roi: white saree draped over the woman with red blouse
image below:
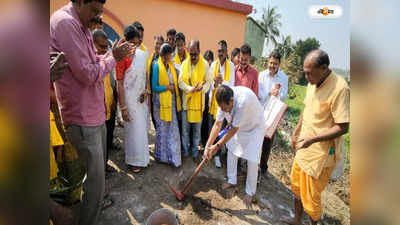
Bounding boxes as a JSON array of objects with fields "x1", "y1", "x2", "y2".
[{"x1": 124, "y1": 49, "x2": 150, "y2": 167}]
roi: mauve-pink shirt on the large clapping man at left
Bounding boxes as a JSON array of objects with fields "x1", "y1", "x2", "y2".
[{"x1": 50, "y1": 3, "x2": 116, "y2": 126}]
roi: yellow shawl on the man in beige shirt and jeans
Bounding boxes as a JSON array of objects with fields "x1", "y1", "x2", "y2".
[{"x1": 182, "y1": 54, "x2": 206, "y2": 123}]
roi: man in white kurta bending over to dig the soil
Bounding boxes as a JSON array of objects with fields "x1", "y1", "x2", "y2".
[{"x1": 204, "y1": 85, "x2": 266, "y2": 208}]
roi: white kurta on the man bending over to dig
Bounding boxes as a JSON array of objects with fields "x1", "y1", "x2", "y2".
[{"x1": 216, "y1": 86, "x2": 266, "y2": 164}]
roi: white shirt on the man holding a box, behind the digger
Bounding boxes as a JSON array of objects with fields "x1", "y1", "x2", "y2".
[{"x1": 258, "y1": 69, "x2": 289, "y2": 106}]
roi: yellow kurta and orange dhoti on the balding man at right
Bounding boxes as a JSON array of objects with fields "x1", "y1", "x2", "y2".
[{"x1": 290, "y1": 73, "x2": 350, "y2": 221}]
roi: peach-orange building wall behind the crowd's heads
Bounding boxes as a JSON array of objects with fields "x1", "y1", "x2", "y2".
[{"x1": 50, "y1": 0, "x2": 247, "y2": 54}]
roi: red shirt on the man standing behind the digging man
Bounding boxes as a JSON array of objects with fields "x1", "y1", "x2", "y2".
[{"x1": 235, "y1": 64, "x2": 258, "y2": 97}]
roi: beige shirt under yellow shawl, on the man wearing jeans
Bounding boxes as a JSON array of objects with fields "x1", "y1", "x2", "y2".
[{"x1": 178, "y1": 58, "x2": 212, "y2": 111}]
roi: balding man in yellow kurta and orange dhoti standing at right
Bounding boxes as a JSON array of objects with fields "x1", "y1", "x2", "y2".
[{"x1": 282, "y1": 50, "x2": 350, "y2": 225}]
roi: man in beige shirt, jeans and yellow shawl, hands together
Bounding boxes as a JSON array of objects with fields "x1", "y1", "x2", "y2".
[{"x1": 178, "y1": 40, "x2": 212, "y2": 162}]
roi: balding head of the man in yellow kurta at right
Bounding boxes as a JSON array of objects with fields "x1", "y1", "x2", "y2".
[{"x1": 303, "y1": 49, "x2": 330, "y2": 85}]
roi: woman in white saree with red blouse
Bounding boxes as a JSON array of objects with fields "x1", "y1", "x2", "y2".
[{"x1": 116, "y1": 25, "x2": 150, "y2": 173}]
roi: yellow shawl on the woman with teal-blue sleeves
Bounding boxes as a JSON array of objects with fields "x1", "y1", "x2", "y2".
[{"x1": 158, "y1": 57, "x2": 181, "y2": 122}]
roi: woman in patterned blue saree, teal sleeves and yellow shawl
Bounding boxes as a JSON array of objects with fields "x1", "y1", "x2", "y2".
[{"x1": 152, "y1": 43, "x2": 181, "y2": 167}]
